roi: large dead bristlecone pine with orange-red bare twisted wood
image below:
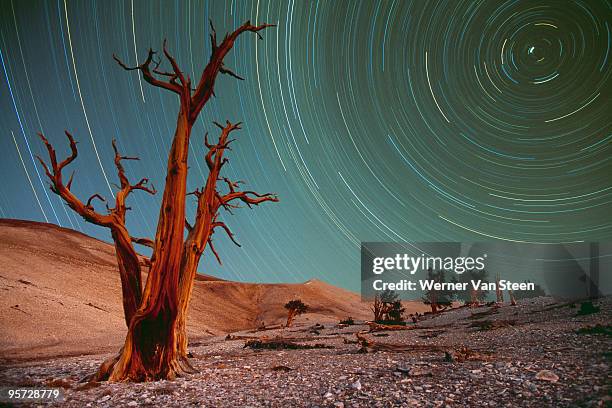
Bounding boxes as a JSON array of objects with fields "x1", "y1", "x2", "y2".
[{"x1": 39, "y1": 21, "x2": 278, "y2": 381}]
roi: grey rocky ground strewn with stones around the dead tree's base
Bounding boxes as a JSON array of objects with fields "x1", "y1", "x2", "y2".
[{"x1": 0, "y1": 298, "x2": 612, "y2": 407}]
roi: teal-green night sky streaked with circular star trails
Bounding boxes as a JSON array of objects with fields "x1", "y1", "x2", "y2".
[{"x1": 0, "y1": 0, "x2": 612, "y2": 290}]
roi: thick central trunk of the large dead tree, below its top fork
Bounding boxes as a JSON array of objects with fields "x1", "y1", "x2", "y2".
[{"x1": 109, "y1": 106, "x2": 191, "y2": 381}]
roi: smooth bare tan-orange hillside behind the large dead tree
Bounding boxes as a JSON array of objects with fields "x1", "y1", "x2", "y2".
[{"x1": 0, "y1": 219, "x2": 430, "y2": 358}]
